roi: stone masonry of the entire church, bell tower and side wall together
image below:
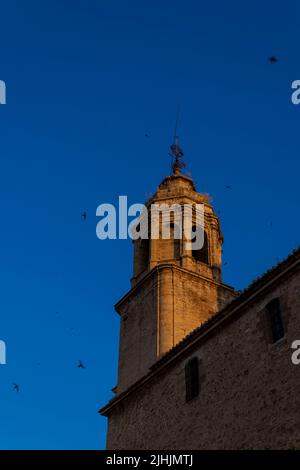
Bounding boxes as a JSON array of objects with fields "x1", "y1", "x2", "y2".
[{"x1": 100, "y1": 168, "x2": 300, "y2": 450}]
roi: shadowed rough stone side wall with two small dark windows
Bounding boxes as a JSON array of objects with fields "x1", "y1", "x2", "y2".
[{"x1": 107, "y1": 271, "x2": 300, "y2": 449}]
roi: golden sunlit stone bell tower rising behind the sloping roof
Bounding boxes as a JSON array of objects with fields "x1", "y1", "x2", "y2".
[{"x1": 114, "y1": 140, "x2": 235, "y2": 394}]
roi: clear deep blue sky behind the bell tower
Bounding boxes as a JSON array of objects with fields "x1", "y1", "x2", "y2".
[{"x1": 0, "y1": 0, "x2": 300, "y2": 449}]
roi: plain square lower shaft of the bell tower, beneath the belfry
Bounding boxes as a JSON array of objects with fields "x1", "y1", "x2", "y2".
[{"x1": 117, "y1": 264, "x2": 234, "y2": 393}]
